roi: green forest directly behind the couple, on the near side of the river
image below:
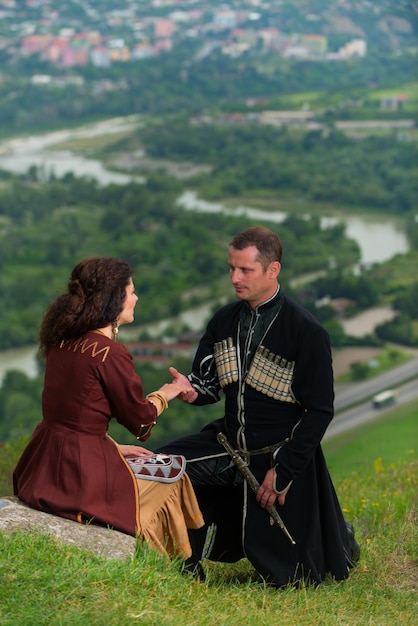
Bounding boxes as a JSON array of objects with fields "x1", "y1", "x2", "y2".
[{"x1": 0, "y1": 168, "x2": 358, "y2": 349}]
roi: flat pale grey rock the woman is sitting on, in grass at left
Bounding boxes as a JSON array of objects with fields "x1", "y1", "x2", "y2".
[{"x1": 0, "y1": 496, "x2": 136, "y2": 559}]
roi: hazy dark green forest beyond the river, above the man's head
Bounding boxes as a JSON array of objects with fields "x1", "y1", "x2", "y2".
[{"x1": 122, "y1": 119, "x2": 418, "y2": 217}]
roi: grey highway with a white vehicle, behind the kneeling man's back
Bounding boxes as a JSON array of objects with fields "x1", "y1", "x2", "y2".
[{"x1": 323, "y1": 358, "x2": 418, "y2": 438}]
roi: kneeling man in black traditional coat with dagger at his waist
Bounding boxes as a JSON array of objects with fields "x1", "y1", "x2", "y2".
[{"x1": 157, "y1": 227, "x2": 358, "y2": 587}]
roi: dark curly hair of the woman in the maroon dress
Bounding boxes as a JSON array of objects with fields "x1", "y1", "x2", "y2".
[{"x1": 39, "y1": 257, "x2": 132, "y2": 356}]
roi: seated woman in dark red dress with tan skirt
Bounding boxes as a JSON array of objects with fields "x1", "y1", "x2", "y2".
[{"x1": 13, "y1": 257, "x2": 203, "y2": 559}]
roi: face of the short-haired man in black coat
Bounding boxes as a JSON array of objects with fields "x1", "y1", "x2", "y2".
[{"x1": 228, "y1": 246, "x2": 280, "y2": 309}]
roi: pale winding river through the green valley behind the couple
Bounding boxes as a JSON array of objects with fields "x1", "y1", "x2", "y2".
[{"x1": 0, "y1": 116, "x2": 409, "y2": 385}]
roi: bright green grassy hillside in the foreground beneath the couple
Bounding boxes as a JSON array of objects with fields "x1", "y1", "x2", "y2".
[{"x1": 0, "y1": 402, "x2": 418, "y2": 626}]
